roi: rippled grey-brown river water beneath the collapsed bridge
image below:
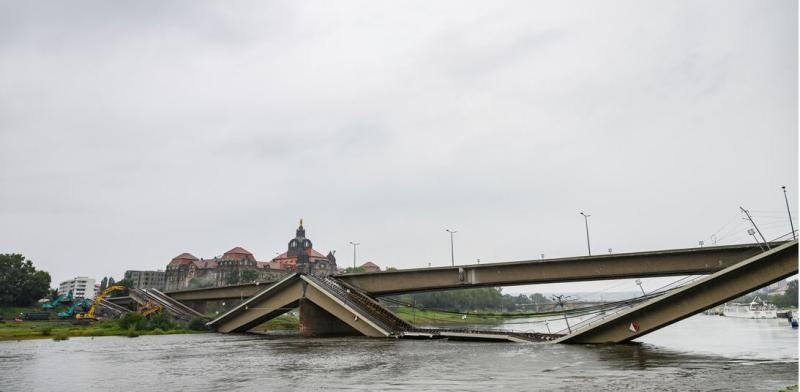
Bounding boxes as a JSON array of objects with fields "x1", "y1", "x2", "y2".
[{"x1": 0, "y1": 315, "x2": 798, "y2": 392}]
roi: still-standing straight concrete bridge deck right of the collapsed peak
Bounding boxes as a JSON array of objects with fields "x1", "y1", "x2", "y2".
[{"x1": 336, "y1": 244, "x2": 777, "y2": 296}]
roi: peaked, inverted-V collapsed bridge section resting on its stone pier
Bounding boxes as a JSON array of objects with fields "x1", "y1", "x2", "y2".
[{"x1": 207, "y1": 273, "x2": 411, "y2": 337}]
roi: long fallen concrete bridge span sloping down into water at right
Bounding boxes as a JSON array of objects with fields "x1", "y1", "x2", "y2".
[{"x1": 555, "y1": 240, "x2": 797, "y2": 343}]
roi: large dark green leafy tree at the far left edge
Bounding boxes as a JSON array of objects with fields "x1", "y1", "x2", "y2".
[{"x1": 0, "y1": 254, "x2": 50, "y2": 306}]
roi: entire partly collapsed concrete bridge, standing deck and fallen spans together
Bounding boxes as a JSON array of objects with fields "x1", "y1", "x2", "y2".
[{"x1": 114, "y1": 241, "x2": 797, "y2": 343}]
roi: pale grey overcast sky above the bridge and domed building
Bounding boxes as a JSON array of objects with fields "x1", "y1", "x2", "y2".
[{"x1": 0, "y1": 0, "x2": 800, "y2": 289}]
